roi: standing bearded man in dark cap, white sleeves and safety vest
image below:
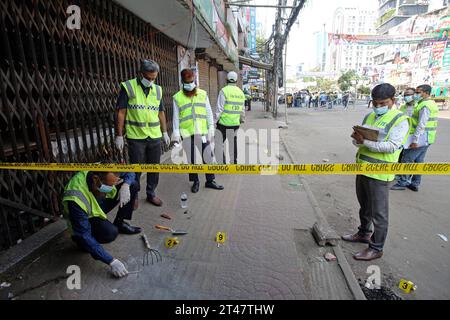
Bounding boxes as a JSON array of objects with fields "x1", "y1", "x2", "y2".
[{"x1": 172, "y1": 69, "x2": 224, "y2": 193}]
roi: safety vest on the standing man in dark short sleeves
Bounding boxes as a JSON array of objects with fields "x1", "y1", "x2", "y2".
[{"x1": 122, "y1": 79, "x2": 162, "y2": 140}]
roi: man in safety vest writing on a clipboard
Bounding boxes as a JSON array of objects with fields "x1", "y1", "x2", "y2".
[{"x1": 342, "y1": 83, "x2": 409, "y2": 261}]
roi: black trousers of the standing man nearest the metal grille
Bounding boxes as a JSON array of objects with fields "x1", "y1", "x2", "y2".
[{"x1": 128, "y1": 138, "x2": 161, "y2": 198}]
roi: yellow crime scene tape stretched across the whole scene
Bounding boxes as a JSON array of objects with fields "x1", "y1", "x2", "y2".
[{"x1": 0, "y1": 163, "x2": 450, "y2": 175}]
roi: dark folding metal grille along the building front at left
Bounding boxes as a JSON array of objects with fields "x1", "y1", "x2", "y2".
[{"x1": 0, "y1": 0, "x2": 178, "y2": 250}]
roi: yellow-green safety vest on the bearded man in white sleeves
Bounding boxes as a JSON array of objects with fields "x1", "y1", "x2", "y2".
[{"x1": 173, "y1": 89, "x2": 208, "y2": 138}]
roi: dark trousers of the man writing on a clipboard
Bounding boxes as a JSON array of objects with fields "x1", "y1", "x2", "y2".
[{"x1": 356, "y1": 175, "x2": 389, "y2": 251}]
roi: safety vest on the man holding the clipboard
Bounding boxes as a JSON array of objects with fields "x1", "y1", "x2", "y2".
[{"x1": 356, "y1": 110, "x2": 408, "y2": 181}]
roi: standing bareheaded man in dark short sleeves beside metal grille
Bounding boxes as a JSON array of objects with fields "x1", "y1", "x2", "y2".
[{"x1": 116, "y1": 60, "x2": 170, "y2": 207}]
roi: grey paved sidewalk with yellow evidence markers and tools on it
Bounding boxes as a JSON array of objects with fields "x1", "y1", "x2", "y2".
[{"x1": 0, "y1": 104, "x2": 353, "y2": 300}]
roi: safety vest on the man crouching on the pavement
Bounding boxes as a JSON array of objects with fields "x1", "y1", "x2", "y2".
[{"x1": 62, "y1": 171, "x2": 117, "y2": 229}]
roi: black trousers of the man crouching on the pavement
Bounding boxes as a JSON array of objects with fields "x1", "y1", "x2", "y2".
[{"x1": 89, "y1": 183, "x2": 138, "y2": 244}]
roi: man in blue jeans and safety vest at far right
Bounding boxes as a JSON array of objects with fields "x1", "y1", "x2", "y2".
[{"x1": 391, "y1": 85, "x2": 439, "y2": 192}]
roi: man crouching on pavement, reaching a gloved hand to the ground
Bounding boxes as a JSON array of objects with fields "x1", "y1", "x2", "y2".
[{"x1": 63, "y1": 171, "x2": 141, "y2": 278}]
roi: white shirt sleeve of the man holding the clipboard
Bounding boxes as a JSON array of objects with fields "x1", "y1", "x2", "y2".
[{"x1": 353, "y1": 112, "x2": 409, "y2": 153}]
